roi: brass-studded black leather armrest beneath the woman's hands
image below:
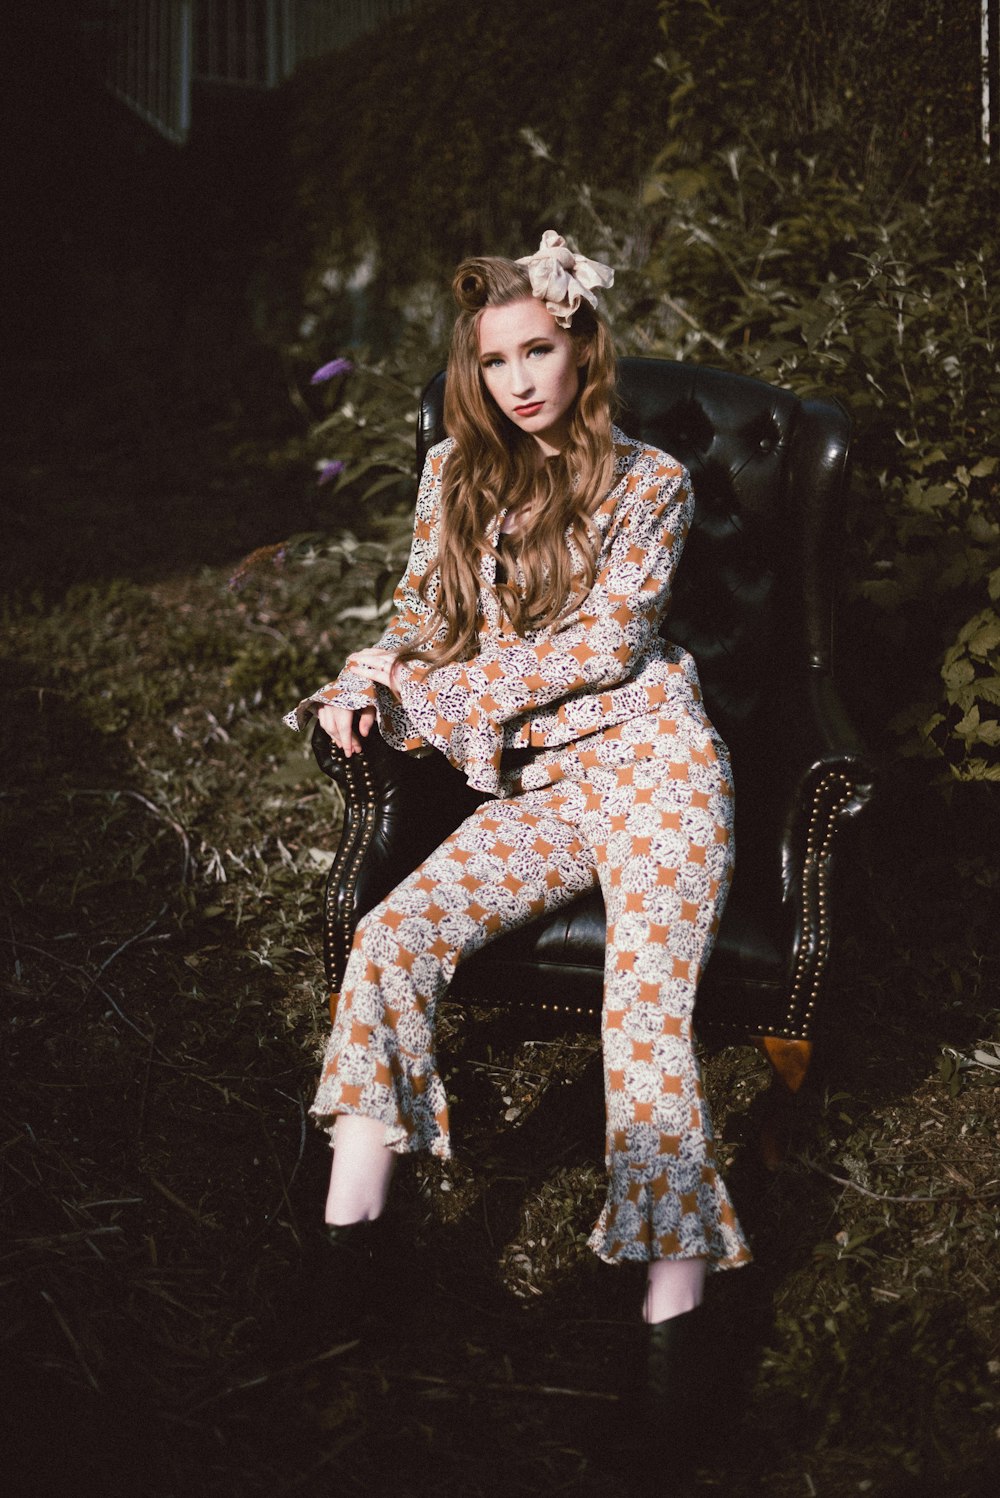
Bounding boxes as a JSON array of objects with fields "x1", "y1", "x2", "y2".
[{"x1": 313, "y1": 724, "x2": 484, "y2": 989}]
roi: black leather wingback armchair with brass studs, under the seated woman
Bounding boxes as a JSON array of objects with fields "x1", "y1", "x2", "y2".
[{"x1": 313, "y1": 358, "x2": 873, "y2": 1091}]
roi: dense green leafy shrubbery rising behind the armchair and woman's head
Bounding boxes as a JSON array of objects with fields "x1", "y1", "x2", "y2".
[{"x1": 264, "y1": 0, "x2": 1000, "y2": 779}]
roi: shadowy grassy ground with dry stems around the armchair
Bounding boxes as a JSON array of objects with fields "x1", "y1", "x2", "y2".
[{"x1": 0, "y1": 404, "x2": 1000, "y2": 1498}]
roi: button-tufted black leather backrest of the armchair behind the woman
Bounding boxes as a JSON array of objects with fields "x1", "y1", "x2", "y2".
[{"x1": 418, "y1": 358, "x2": 850, "y2": 753}]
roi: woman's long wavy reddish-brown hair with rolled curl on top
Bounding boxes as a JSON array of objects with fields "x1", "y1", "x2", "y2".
[{"x1": 403, "y1": 256, "x2": 617, "y2": 665}]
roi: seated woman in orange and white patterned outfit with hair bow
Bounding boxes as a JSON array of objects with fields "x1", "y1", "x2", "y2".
[{"x1": 289, "y1": 231, "x2": 750, "y2": 1414}]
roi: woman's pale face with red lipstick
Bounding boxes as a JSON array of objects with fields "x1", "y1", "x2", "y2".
[{"x1": 479, "y1": 297, "x2": 590, "y2": 457}]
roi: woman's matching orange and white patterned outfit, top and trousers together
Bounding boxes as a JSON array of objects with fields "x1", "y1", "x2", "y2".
[{"x1": 286, "y1": 428, "x2": 750, "y2": 1267}]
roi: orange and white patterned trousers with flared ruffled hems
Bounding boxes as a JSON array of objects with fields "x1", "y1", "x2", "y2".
[{"x1": 311, "y1": 710, "x2": 750, "y2": 1269}]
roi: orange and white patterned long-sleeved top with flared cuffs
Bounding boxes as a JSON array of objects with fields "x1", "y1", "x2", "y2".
[{"x1": 284, "y1": 427, "x2": 705, "y2": 795}]
